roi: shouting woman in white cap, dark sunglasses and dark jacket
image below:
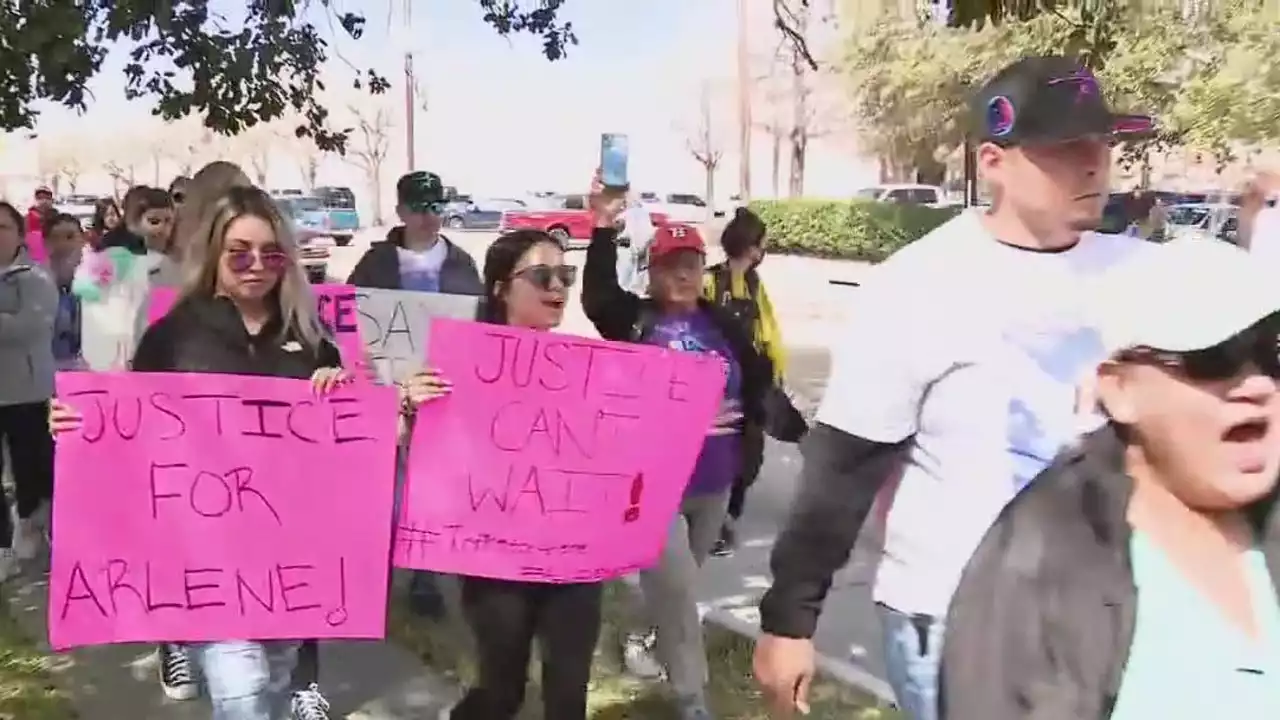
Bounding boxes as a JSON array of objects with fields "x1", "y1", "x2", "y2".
[{"x1": 938, "y1": 240, "x2": 1280, "y2": 720}]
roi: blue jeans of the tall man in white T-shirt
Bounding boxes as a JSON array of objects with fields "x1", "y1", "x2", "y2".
[{"x1": 876, "y1": 605, "x2": 943, "y2": 720}]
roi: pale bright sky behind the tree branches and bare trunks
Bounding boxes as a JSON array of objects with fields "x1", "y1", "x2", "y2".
[{"x1": 7, "y1": 0, "x2": 870, "y2": 206}]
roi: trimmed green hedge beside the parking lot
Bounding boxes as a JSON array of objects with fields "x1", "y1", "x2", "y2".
[{"x1": 751, "y1": 200, "x2": 960, "y2": 261}]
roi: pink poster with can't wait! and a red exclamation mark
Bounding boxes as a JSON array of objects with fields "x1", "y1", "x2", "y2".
[{"x1": 393, "y1": 318, "x2": 724, "y2": 583}]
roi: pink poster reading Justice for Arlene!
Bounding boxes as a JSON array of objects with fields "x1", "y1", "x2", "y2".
[{"x1": 49, "y1": 373, "x2": 397, "y2": 648}]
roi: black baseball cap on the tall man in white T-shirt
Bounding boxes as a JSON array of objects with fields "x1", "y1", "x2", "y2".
[{"x1": 970, "y1": 55, "x2": 1156, "y2": 147}]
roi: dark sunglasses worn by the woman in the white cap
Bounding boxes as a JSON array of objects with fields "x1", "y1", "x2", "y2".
[{"x1": 1121, "y1": 323, "x2": 1280, "y2": 382}]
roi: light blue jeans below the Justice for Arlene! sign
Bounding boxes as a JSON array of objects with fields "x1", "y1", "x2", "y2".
[{"x1": 188, "y1": 641, "x2": 298, "y2": 720}]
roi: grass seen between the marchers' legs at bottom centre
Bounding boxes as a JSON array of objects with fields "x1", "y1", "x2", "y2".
[{"x1": 389, "y1": 583, "x2": 899, "y2": 720}]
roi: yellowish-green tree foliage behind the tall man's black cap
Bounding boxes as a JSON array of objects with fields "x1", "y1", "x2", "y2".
[{"x1": 844, "y1": 0, "x2": 1280, "y2": 178}]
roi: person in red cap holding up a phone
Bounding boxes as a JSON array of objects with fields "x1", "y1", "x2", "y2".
[{"x1": 582, "y1": 174, "x2": 773, "y2": 720}]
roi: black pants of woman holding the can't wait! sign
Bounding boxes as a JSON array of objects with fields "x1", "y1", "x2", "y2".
[{"x1": 449, "y1": 578, "x2": 604, "y2": 720}]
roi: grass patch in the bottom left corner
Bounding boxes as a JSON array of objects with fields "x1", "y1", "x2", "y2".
[{"x1": 0, "y1": 591, "x2": 77, "y2": 720}]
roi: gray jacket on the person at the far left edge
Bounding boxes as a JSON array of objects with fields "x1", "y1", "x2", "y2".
[{"x1": 0, "y1": 251, "x2": 58, "y2": 405}]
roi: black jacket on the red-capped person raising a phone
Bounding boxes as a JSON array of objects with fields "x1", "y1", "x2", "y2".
[{"x1": 582, "y1": 228, "x2": 773, "y2": 425}]
